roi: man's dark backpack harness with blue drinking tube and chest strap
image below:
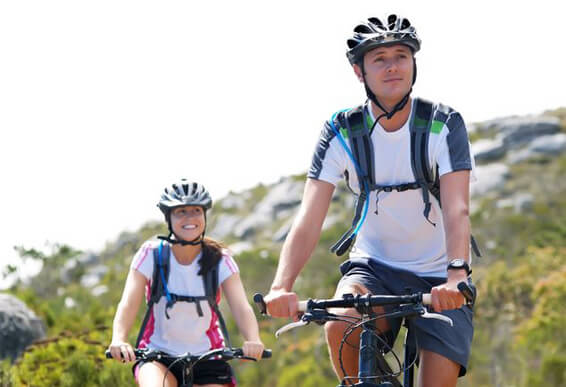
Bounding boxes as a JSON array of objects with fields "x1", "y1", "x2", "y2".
[{"x1": 329, "y1": 98, "x2": 481, "y2": 257}]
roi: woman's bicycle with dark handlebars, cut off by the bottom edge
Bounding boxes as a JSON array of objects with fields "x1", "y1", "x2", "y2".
[{"x1": 105, "y1": 348, "x2": 271, "y2": 387}]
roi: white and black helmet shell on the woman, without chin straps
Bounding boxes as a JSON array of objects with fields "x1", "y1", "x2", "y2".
[{"x1": 157, "y1": 179, "x2": 212, "y2": 218}]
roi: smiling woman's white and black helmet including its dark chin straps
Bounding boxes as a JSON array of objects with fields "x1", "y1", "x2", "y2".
[{"x1": 157, "y1": 179, "x2": 212, "y2": 245}]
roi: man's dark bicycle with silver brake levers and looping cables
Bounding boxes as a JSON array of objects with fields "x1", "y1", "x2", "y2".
[{"x1": 254, "y1": 282, "x2": 475, "y2": 387}]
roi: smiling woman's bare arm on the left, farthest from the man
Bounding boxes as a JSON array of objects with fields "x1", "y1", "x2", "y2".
[{"x1": 109, "y1": 269, "x2": 147, "y2": 361}]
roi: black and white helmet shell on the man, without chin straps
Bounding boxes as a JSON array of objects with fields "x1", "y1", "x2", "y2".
[{"x1": 346, "y1": 14, "x2": 421, "y2": 65}]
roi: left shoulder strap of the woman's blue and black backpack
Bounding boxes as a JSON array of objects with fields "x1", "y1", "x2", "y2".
[{"x1": 136, "y1": 241, "x2": 171, "y2": 348}]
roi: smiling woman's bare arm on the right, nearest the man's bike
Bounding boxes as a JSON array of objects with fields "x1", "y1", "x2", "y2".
[{"x1": 222, "y1": 273, "x2": 264, "y2": 359}]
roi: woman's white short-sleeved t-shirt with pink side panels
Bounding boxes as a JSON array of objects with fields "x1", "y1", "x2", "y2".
[{"x1": 130, "y1": 241, "x2": 239, "y2": 356}]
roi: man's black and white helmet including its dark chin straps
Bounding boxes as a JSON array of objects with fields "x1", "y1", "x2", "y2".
[{"x1": 346, "y1": 14, "x2": 421, "y2": 123}]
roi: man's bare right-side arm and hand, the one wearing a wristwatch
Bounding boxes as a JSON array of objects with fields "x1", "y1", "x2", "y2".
[{"x1": 431, "y1": 170, "x2": 470, "y2": 312}]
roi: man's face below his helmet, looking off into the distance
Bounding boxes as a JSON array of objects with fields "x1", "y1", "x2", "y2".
[{"x1": 354, "y1": 44, "x2": 414, "y2": 104}]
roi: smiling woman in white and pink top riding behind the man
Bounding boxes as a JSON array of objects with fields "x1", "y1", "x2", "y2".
[{"x1": 109, "y1": 179, "x2": 264, "y2": 387}]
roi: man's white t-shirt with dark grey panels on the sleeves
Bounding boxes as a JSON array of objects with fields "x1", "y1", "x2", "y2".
[{"x1": 307, "y1": 100, "x2": 474, "y2": 277}]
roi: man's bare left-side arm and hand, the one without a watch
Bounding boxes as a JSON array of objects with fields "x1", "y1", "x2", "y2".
[{"x1": 265, "y1": 179, "x2": 334, "y2": 317}]
